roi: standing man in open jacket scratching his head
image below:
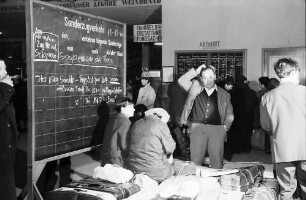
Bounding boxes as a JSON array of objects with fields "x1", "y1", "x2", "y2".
[{"x1": 178, "y1": 64, "x2": 234, "y2": 169}]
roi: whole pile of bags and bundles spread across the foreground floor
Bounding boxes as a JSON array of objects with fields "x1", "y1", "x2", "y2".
[{"x1": 44, "y1": 164, "x2": 279, "y2": 200}]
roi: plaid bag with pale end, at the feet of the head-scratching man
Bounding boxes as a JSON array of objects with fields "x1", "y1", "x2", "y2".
[{"x1": 220, "y1": 165, "x2": 265, "y2": 192}]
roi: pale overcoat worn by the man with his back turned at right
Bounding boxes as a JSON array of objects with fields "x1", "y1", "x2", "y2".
[{"x1": 260, "y1": 82, "x2": 306, "y2": 163}]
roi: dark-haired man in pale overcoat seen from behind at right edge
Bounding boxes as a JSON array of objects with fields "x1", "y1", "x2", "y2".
[{"x1": 260, "y1": 58, "x2": 306, "y2": 200}]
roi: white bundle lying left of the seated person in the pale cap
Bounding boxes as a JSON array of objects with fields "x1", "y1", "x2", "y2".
[{"x1": 93, "y1": 164, "x2": 134, "y2": 183}]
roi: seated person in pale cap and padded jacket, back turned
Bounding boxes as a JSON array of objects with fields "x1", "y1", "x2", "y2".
[{"x1": 127, "y1": 108, "x2": 176, "y2": 181}]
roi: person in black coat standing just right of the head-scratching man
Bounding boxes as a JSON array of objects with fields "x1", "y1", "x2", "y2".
[{"x1": 229, "y1": 76, "x2": 259, "y2": 153}]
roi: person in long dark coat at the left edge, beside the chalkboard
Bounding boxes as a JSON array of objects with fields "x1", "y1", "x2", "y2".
[{"x1": 0, "y1": 60, "x2": 17, "y2": 200}]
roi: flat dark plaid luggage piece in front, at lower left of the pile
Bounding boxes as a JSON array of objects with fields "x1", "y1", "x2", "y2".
[{"x1": 44, "y1": 178, "x2": 140, "y2": 200}]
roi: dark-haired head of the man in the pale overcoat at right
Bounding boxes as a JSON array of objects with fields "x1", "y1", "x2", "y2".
[{"x1": 274, "y1": 58, "x2": 299, "y2": 78}]
